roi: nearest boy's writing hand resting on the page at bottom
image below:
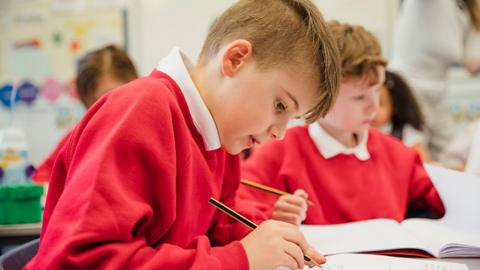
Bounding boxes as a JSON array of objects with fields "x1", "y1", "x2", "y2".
[{"x1": 240, "y1": 220, "x2": 325, "y2": 270}]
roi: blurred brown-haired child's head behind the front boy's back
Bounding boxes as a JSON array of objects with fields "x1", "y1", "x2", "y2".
[{"x1": 75, "y1": 45, "x2": 138, "y2": 109}]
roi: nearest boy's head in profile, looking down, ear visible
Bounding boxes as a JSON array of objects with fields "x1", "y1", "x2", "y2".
[{"x1": 193, "y1": 0, "x2": 340, "y2": 153}]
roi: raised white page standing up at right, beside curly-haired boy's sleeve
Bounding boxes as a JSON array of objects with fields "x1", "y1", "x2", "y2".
[{"x1": 425, "y1": 164, "x2": 480, "y2": 234}]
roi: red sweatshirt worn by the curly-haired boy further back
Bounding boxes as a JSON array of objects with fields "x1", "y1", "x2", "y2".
[{"x1": 239, "y1": 126, "x2": 444, "y2": 224}]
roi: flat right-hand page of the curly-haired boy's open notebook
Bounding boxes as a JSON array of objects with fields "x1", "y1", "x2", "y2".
[{"x1": 402, "y1": 218, "x2": 480, "y2": 257}]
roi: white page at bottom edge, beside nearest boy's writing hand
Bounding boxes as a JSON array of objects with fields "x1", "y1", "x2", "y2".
[{"x1": 304, "y1": 254, "x2": 468, "y2": 270}]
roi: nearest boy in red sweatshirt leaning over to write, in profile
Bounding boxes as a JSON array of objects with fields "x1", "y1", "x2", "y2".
[{"x1": 27, "y1": 0, "x2": 339, "y2": 270}]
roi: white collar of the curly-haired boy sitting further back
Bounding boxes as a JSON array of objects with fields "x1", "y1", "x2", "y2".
[{"x1": 308, "y1": 123, "x2": 370, "y2": 160}]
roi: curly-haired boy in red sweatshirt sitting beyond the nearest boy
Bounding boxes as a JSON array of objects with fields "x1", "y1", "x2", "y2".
[{"x1": 240, "y1": 22, "x2": 444, "y2": 225}]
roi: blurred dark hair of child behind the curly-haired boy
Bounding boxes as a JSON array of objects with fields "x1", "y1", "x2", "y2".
[{"x1": 385, "y1": 70, "x2": 424, "y2": 139}]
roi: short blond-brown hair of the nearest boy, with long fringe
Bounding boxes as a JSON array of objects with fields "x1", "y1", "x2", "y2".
[{"x1": 199, "y1": 0, "x2": 340, "y2": 122}]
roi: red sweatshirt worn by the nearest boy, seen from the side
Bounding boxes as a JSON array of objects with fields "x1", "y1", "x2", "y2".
[{"x1": 25, "y1": 71, "x2": 265, "y2": 270}]
